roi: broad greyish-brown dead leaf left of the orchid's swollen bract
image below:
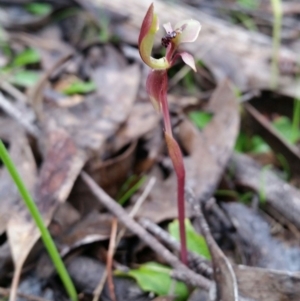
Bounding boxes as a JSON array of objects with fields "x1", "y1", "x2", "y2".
[{"x1": 44, "y1": 65, "x2": 140, "y2": 156}]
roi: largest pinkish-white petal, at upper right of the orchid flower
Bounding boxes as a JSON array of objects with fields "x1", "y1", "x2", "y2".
[{"x1": 174, "y1": 19, "x2": 201, "y2": 45}]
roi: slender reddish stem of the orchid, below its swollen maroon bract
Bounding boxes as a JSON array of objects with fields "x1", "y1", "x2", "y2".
[{"x1": 160, "y1": 92, "x2": 187, "y2": 264}]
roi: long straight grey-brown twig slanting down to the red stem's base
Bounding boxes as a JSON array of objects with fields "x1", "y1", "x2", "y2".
[{"x1": 81, "y1": 171, "x2": 211, "y2": 290}]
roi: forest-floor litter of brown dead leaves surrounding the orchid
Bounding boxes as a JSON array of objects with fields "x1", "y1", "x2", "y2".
[{"x1": 0, "y1": 0, "x2": 300, "y2": 301}]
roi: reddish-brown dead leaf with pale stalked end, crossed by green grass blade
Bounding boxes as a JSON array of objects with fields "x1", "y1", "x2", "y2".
[{"x1": 7, "y1": 130, "x2": 86, "y2": 300}]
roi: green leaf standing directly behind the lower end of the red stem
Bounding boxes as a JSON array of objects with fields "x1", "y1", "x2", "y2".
[{"x1": 168, "y1": 219, "x2": 211, "y2": 259}]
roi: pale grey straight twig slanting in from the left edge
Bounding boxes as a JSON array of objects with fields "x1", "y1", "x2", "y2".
[{"x1": 0, "y1": 92, "x2": 40, "y2": 139}]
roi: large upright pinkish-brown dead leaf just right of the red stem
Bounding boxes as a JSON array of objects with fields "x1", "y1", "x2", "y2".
[{"x1": 179, "y1": 81, "x2": 240, "y2": 200}]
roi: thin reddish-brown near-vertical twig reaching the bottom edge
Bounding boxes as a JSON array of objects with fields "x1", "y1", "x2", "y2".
[{"x1": 106, "y1": 218, "x2": 118, "y2": 301}]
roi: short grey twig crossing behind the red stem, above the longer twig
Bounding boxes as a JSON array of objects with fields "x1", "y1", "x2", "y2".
[{"x1": 139, "y1": 218, "x2": 213, "y2": 279}]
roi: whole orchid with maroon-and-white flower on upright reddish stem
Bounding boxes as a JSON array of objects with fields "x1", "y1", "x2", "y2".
[{"x1": 138, "y1": 4, "x2": 201, "y2": 263}]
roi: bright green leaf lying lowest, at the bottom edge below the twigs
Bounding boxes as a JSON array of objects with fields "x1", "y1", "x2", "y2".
[{"x1": 115, "y1": 262, "x2": 189, "y2": 301}]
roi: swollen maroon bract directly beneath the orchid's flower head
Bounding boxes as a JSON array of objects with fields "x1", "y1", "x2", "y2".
[{"x1": 146, "y1": 70, "x2": 168, "y2": 112}]
